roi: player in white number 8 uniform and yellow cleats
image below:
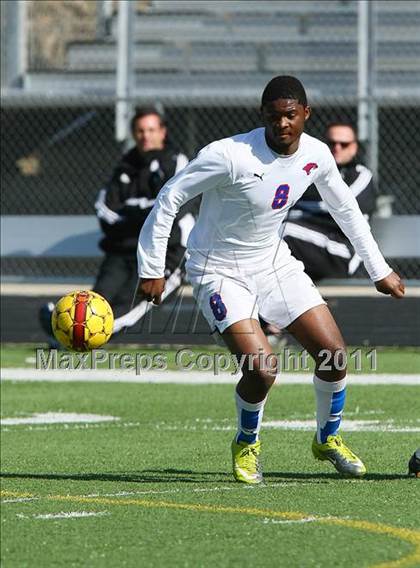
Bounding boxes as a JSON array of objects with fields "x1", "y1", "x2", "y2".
[{"x1": 138, "y1": 76, "x2": 404, "y2": 483}]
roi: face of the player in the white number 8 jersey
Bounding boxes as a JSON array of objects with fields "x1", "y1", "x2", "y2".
[{"x1": 261, "y1": 99, "x2": 311, "y2": 154}]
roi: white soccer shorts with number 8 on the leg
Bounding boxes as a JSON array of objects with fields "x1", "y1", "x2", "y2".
[{"x1": 187, "y1": 255, "x2": 325, "y2": 333}]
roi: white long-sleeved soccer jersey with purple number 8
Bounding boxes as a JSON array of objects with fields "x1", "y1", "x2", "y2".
[{"x1": 138, "y1": 128, "x2": 392, "y2": 281}]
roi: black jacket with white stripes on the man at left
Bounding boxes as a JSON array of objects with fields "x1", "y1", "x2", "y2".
[{"x1": 95, "y1": 146, "x2": 197, "y2": 271}]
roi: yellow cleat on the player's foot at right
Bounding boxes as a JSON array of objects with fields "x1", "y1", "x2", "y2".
[{"x1": 312, "y1": 435, "x2": 366, "y2": 477}]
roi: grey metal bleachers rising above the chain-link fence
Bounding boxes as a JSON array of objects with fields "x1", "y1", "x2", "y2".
[{"x1": 25, "y1": 0, "x2": 420, "y2": 97}]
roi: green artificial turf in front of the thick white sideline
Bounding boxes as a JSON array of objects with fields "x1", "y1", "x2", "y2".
[{"x1": 1, "y1": 381, "x2": 420, "y2": 568}]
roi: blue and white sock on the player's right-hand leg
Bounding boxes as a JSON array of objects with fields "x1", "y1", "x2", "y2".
[{"x1": 314, "y1": 376, "x2": 346, "y2": 444}]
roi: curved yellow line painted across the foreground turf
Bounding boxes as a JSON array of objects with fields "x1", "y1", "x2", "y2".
[{"x1": 0, "y1": 491, "x2": 420, "y2": 568}]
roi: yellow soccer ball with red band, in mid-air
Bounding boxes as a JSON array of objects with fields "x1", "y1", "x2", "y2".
[{"x1": 51, "y1": 290, "x2": 114, "y2": 351}]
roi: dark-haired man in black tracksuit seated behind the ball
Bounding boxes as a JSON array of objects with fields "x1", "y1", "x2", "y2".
[{"x1": 93, "y1": 109, "x2": 194, "y2": 333}]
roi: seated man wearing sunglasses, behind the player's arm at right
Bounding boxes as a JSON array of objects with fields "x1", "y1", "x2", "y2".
[{"x1": 283, "y1": 122, "x2": 375, "y2": 282}]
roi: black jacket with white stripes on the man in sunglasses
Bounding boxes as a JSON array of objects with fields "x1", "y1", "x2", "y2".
[{"x1": 288, "y1": 160, "x2": 376, "y2": 242}]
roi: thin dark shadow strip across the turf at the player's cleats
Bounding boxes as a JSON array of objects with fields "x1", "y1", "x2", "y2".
[{"x1": 0, "y1": 469, "x2": 408, "y2": 483}]
